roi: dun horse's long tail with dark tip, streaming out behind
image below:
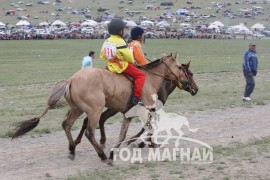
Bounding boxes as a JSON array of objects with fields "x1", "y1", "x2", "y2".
[{"x1": 12, "y1": 80, "x2": 70, "y2": 139}]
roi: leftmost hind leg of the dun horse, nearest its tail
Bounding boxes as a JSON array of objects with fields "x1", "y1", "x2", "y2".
[{"x1": 62, "y1": 108, "x2": 83, "y2": 159}]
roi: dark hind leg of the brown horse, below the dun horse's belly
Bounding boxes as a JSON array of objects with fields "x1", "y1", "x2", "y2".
[{"x1": 99, "y1": 109, "x2": 118, "y2": 145}]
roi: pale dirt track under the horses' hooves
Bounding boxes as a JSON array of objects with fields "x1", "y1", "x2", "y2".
[{"x1": 0, "y1": 104, "x2": 270, "y2": 179}]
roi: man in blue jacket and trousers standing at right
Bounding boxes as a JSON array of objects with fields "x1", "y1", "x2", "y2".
[{"x1": 243, "y1": 43, "x2": 258, "y2": 101}]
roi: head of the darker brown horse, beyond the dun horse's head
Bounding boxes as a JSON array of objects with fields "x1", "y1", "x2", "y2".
[{"x1": 179, "y1": 61, "x2": 199, "y2": 96}]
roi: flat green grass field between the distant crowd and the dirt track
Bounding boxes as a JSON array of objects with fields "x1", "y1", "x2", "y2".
[{"x1": 0, "y1": 39, "x2": 270, "y2": 137}]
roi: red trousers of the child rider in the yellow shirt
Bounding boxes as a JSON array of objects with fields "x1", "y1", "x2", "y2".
[{"x1": 123, "y1": 63, "x2": 145, "y2": 99}]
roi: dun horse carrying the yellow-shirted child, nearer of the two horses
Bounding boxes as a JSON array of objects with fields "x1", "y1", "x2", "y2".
[{"x1": 12, "y1": 52, "x2": 194, "y2": 164}]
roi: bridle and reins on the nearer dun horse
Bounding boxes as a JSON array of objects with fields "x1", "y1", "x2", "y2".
[{"x1": 139, "y1": 56, "x2": 186, "y2": 89}]
